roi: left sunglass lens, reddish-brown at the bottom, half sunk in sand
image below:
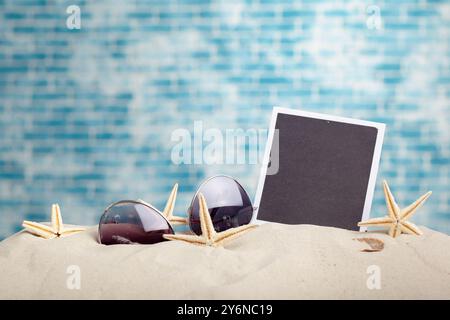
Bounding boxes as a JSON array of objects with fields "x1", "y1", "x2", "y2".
[{"x1": 98, "y1": 201, "x2": 174, "y2": 245}]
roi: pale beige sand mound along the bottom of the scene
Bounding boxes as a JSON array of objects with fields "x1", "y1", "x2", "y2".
[{"x1": 0, "y1": 224, "x2": 450, "y2": 299}]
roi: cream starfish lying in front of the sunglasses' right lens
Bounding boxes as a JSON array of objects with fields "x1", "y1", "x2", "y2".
[{"x1": 163, "y1": 193, "x2": 256, "y2": 247}]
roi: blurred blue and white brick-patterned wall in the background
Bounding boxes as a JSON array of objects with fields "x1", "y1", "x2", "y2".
[{"x1": 0, "y1": 0, "x2": 450, "y2": 238}]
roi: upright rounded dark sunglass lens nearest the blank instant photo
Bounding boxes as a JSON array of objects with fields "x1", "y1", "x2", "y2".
[{"x1": 188, "y1": 176, "x2": 253, "y2": 235}]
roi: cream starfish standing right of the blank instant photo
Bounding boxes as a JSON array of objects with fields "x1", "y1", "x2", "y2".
[{"x1": 358, "y1": 181, "x2": 431, "y2": 238}]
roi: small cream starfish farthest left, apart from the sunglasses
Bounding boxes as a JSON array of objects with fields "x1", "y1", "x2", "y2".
[{"x1": 22, "y1": 204, "x2": 86, "y2": 239}]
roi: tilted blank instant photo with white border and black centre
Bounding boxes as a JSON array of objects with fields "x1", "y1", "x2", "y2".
[{"x1": 254, "y1": 107, "x2": 385, "y2": 231}]
